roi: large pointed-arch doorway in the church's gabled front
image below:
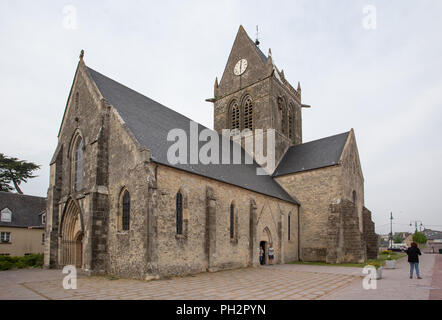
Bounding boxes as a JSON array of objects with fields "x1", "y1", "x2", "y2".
[{"x1": 60, "y1": 200, "x2": 83, "y2": 268}]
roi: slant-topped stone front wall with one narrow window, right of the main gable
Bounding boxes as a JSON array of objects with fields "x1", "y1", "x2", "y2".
[{"x1": 107, "y1": 107, "x2": 155, "y2": 278}]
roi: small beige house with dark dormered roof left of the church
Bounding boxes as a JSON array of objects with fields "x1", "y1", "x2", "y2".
[{"x1": 0, "y1": 191, "x2": 46, "y2": 256}]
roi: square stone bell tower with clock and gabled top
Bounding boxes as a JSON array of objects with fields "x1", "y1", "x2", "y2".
[{"x1": 207, "y1": 26, "x2": 308, "y2": 170}]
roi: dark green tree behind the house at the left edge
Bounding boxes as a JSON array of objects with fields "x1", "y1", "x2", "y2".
[{"x1": 0, "y1": 153, "x2": 40, "y2": 194}]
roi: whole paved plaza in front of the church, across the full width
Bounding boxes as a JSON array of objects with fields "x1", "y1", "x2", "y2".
[{"x1": 0, "y1": 255, "x2": 442, "y2": 300}]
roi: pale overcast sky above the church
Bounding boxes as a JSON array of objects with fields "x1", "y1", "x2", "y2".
[{"x1": 0, "y1": 0, "x2": 442, "y2": 233}]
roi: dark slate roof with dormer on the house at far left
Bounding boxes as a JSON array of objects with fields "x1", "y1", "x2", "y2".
[{"x1": 0, "y1": 191, "x2": 46, "y2": 228}]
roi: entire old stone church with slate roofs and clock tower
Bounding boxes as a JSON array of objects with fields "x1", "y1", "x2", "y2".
[{"x1": 45, "y1": 26, "x2": 378, "y2": 279}]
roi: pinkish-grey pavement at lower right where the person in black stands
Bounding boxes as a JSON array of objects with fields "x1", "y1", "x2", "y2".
[{"x1": 320, "y1": 254, "x2": 442, "y2": 300}]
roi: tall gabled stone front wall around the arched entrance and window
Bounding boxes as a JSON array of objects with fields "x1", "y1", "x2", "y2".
[{"x1": 45, "y1": 60, "x2": 107, "y2": 271}]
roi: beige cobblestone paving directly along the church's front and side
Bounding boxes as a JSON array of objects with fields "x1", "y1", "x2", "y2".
[{"x1": 0, "y1": 265, "x2": 361, "y2": 300}]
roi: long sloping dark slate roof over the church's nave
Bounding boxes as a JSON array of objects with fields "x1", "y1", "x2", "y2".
[{"x1": 87, "y1": 67, "x2": 299, "y2": 203}]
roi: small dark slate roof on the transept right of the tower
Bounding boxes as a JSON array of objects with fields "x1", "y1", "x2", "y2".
[{"x1": 273, "y1": 132, "x2": 350, "y2": 177}]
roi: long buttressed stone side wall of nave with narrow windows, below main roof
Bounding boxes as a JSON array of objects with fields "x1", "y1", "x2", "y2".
[{"x1": 153, "y1": 165, "x2": 298, "y2": 275}]
